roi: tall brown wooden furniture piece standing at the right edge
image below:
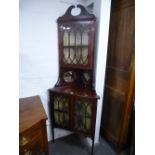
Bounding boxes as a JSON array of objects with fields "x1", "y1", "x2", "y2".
[{"x1": 100, "y1": 0, "x2": 135, "y2": 151}]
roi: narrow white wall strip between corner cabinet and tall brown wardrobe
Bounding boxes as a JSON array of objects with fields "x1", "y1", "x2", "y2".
[{"x1": 87, "y1": 0, "x2": 111, "y2": 143}]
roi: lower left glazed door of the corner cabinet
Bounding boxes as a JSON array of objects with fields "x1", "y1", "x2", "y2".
[{"x1": 53, "y1": 94, "x2": 70, "y2": 128}]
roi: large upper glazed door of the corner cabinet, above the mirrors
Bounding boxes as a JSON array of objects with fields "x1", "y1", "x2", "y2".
[{"x1": 59, "y1": 21, "x2": 94, "y2": 68}]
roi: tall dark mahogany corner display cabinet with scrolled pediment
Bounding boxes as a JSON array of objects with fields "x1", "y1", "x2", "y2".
[{"x1": 49, "y1": 5, "x2": 99, "y2": 154}]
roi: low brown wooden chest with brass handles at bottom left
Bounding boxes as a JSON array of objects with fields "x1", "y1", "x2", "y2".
[{"x1": 19, "y1": 96, "x2": 48, "y2": 155}]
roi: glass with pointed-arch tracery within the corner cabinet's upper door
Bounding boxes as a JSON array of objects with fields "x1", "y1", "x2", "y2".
[{"x1": 63, "y1": 26, "x2": 89, "y2": 65}]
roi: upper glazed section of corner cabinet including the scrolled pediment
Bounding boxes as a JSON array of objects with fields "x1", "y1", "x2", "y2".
[{"x1": 58, "y1": 5, "x2": 96, "y2": 69}]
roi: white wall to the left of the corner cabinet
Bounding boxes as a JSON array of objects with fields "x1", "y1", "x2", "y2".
[{"x1": 19, "y1": 0, "x2": 85, "y2": 140}]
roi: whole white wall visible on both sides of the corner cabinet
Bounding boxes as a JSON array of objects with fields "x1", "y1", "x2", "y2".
[{"x1": 19, "y1": 0, "x2": 110, "y2": 142}]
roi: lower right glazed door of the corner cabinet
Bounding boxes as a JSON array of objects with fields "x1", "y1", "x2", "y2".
[{"x1": 73, "y1": 98, "x2": 96, "y2": 135}]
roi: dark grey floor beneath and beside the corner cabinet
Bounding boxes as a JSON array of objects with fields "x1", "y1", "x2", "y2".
[{"x1": 49, "y1": 134, "x2": 130, "y2": 155}]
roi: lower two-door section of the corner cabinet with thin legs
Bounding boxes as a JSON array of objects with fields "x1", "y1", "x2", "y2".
[{"x1": 49, "y1": 89, "x2": 98, "y2": 155}]
